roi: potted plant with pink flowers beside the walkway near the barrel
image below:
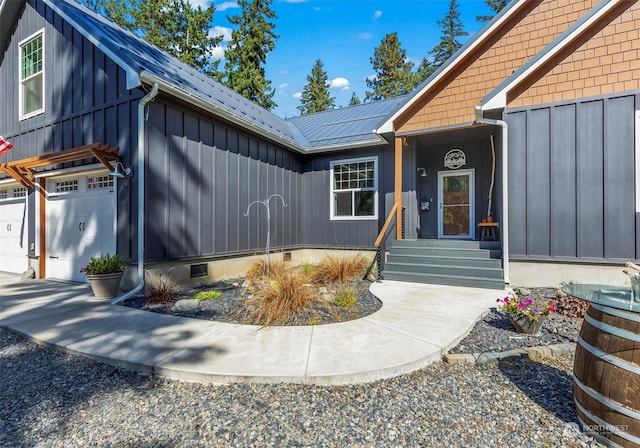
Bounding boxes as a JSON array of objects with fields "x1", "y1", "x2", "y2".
[{"x1": 496, "y1": 293, "x2": 555, "y2": 336}]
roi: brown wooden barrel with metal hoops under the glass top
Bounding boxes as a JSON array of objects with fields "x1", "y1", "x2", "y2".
[{"x1": 573, "y1": 303, "x2": 640, "y2": 448}]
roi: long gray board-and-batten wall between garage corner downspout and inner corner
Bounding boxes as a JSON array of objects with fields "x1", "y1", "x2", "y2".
[{"x1": 145, "y1": 99, "x2": 302, "y2": 262}]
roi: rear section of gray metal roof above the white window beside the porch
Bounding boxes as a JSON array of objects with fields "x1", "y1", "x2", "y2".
[{"x1": 287, "y1": 95, "x2": 409, "y2": 150}]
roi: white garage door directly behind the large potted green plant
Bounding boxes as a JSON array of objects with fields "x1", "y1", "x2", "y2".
[{"x1": 46, "y1": 174, "x2": 116, "y2": 282}]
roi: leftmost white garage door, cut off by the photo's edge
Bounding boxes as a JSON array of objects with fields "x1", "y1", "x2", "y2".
[{"x1": 0, "y1": 183, "x2": 29, "y2": 273}]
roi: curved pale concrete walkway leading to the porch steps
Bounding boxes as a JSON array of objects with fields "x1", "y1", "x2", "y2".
[{"x1": 0, "y1": 273, "x2": 505, "y2": 385}]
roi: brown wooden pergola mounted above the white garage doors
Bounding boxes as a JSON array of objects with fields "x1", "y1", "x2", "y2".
[{"x1": 0, "y1": 143, "x2": 120, "y2": 188}]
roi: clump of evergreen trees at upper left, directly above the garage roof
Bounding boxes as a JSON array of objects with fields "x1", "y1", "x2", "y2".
[{"x1": 79, "y1": 0, "x2": 222, "y2": 76}]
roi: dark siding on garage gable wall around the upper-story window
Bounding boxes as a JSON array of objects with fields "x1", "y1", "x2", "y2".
[{"x1": 0, "y1": 0, "x2": 143, "y2": 258}]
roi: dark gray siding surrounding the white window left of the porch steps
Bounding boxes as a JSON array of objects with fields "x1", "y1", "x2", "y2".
[{"x1": 302, "y1": 145, "x2": 394, "y2": 248}]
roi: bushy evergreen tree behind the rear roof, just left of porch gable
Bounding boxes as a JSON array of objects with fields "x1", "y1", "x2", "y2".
[{"x1": 365, "y1": 32, "x2": 418, "y2": 101}]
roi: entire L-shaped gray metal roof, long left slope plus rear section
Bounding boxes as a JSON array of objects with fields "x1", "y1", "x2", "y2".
[{"x1": 26, "y1": 0, "x2": 409, "y2": 152}]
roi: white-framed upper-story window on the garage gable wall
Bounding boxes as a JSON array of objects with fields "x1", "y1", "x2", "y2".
[{"x1": 19, "y1": 31, "x2": 44, "y2": 119}]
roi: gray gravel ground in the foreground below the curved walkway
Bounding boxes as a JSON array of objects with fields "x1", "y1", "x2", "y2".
[{"x1": 0, "y1": 328, "x2": 597, "y2": 448}]
